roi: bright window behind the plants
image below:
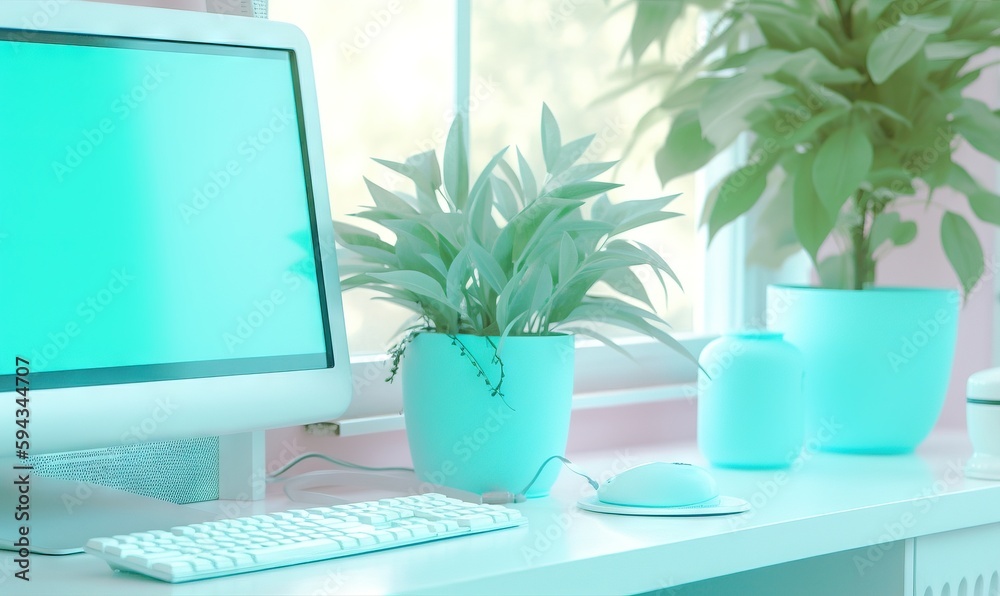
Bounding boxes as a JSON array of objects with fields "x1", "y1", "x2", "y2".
[{"x1": 270, "y1": 0, "x2": 796, "y2": 428}]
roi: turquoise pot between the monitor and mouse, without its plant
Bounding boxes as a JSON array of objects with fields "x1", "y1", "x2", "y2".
[{"x1": 401, "y1": 333, "x2": 575, "y2": 497}]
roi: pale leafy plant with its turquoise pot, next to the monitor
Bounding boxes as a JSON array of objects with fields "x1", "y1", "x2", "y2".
[{"x1": 334, "y1": 106, "x2": 683, "y2": 496}]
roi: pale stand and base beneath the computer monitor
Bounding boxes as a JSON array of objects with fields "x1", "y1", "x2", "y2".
[{"x1": 0, "y1": 431, "x2": 264, "y2": 555}]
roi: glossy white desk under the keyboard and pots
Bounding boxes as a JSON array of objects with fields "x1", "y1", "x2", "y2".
[{"x1": 0, "y1": 435, "x2": 1000, "y2": 596}]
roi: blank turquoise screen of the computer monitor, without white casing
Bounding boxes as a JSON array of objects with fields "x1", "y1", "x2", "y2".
[{"x1": 0, "y1": 32, "x2": 332, "y2": 388}]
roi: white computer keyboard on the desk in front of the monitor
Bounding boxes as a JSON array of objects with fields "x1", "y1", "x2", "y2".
[{"x1": 85, "y1": 493, "x2": 527, "y2": 583}]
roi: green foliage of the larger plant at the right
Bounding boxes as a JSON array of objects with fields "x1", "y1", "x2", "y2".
[{"x1": 628, "y1": 0, "x2": 1000, "y2": 292}]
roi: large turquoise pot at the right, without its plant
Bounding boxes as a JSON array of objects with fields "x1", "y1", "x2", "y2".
[{"x1": 767, "y1": 286, "x2": 961, "y2": 454}]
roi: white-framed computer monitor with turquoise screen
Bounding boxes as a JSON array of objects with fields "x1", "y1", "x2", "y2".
[{"x1": 0, "y1": 1, "x2": 351, "y2": 548}]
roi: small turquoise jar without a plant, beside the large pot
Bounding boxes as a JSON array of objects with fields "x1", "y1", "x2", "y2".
[{"x1": 698, "y1": 331, "x2": 805, "y2": 468}]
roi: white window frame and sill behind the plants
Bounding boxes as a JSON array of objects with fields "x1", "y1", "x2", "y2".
[{"x1": 324, "y1": 0, "x2": 808, "y2": 436}]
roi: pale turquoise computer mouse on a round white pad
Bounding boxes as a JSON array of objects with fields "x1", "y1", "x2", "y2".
[{"x1": 597, "y1": 462, "x2": 719, "y2": 507}]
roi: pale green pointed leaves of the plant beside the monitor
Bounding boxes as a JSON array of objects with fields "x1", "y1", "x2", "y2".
[{"x1": 334, "y1": 105, "x2": 686, "y2": 365}]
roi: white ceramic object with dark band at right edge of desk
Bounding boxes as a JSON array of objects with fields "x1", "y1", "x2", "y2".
[{"x1": 965, "y1": 368, "x2": 1000, "y2": 480}]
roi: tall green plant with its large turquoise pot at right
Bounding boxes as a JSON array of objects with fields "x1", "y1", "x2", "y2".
[{"x1": 629, "y1": 0, "x2": 1000, "y2": 452}]
